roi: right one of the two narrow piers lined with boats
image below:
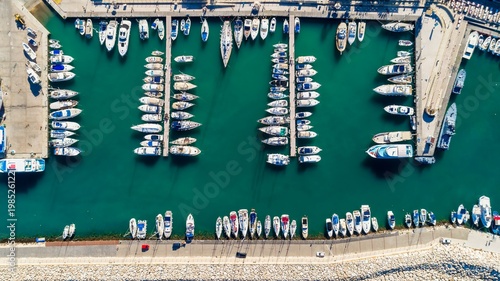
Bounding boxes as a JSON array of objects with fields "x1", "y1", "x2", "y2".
[{"x1": 288, "y1": 15, "x2": 297, "y2": 157}]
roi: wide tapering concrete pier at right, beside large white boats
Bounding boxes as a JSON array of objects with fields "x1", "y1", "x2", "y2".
[{"x1": 415, "y1": 6, "x2": 467, "y2": 156}]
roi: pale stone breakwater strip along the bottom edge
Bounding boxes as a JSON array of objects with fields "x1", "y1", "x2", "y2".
[{"x1": 0, "y1": 244, "x2": 500, "y2": 281}]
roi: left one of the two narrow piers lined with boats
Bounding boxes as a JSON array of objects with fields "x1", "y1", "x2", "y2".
[{"x1": 163, "y1": 16, "x2": 172, "y2": 157}]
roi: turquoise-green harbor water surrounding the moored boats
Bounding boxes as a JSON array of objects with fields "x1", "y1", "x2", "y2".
[{"x1": 0, "y1": 6, "x2": 500, "y2": 237}]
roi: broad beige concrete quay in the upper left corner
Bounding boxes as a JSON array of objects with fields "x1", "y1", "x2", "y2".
[{"x1": 0, "y1": 1, "x2": 49, "y2": 159}]
